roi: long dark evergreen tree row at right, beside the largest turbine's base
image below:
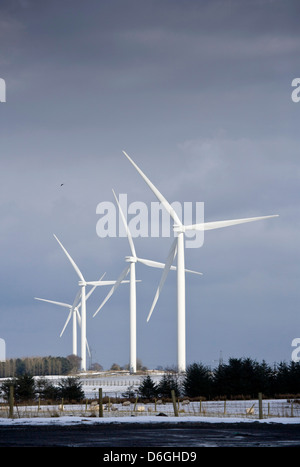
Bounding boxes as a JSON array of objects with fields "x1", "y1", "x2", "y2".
[{"x1": 138, "y1": 358, "x2": 300, "y2": 399}]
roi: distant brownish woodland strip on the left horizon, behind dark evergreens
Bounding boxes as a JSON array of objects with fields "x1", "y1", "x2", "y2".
[{"x1": 0, "y1": 355, "x2": 80, "y2": 378}]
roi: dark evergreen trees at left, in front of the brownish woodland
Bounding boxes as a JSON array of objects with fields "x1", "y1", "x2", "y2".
[{"x1": 0, "y1": 374, "x2": 84, "y2": 403}]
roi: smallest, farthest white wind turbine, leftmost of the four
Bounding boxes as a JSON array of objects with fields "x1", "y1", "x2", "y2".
[{"x1": 34, "y1": 273, "x2": 105, "y2": 356}]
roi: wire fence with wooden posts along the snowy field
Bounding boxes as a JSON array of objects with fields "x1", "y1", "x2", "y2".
[{"x1": 0, "y1": 400, "x2": 300, "y2": 419}]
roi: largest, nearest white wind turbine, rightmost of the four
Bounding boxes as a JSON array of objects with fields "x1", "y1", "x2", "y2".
[{"x1": 123, "y1": 151, "x2": 278, "y2": 372}]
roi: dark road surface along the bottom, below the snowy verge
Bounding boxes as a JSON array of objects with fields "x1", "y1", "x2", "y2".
[{"x1": 0, "y1": 423, "x2": 300, "y2": 448}]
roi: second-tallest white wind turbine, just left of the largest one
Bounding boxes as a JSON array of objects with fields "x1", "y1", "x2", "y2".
[{"x1": 93, "y1": 190, "x2": 202, "y2": 373}]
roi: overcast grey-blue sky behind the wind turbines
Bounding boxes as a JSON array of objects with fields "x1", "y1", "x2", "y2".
[{"x1": 0, "y1": 0, "x2": 300, "y2": 368}]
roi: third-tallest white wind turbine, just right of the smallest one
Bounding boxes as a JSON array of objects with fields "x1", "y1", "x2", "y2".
[{"x1": 54, "y1": 235, "x2": 128, "y2": 371}]
